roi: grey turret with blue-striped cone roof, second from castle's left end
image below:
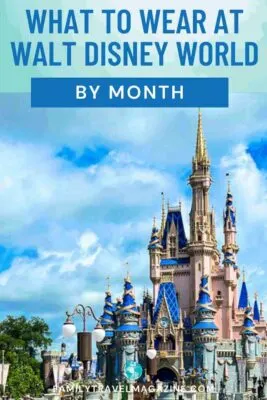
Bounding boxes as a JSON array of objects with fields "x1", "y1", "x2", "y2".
[{"x1": 115, "y1": 275, "x2": 142, "y2": 381}]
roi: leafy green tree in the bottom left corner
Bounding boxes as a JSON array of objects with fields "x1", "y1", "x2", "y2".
[{"x1": 0, "y1": 315, "x2": 52, "y2": 398}]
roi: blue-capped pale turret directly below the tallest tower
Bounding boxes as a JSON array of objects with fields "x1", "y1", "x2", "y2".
[{"x1": 192, "y1": 275, "x2": 218, "y2": 383}]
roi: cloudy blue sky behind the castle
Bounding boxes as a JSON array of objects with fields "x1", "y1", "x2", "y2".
[{"x1": 0, "y1": 94, "x2": 267, "y2": 348}]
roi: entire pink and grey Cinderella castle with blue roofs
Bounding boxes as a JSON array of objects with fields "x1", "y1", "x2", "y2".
[{"x1": 97, "y1": 112, "x2": 267, "y2": 399}]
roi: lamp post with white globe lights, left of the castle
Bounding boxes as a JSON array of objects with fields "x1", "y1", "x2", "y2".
[{"x1": 62, "y1": 304, "x2": 105, "y2": 379}]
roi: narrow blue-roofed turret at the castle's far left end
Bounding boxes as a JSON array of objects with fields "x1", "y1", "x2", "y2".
[{"x1": 97, "y1": 286, "x2": 115, "y2": 383}]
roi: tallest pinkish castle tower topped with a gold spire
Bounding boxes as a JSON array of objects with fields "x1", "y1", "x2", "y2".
[{"x1": 188, "y1": 112, "x2": 219, "y2": 311}]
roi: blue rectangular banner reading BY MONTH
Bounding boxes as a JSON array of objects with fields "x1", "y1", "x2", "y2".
[{"x1": 31, "y1": 78, "x2": 229, "y2": 108}]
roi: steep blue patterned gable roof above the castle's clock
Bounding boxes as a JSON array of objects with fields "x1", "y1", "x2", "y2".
[{"x1": 153, "y1": 282, "x2": 180, "y2": 324}]
